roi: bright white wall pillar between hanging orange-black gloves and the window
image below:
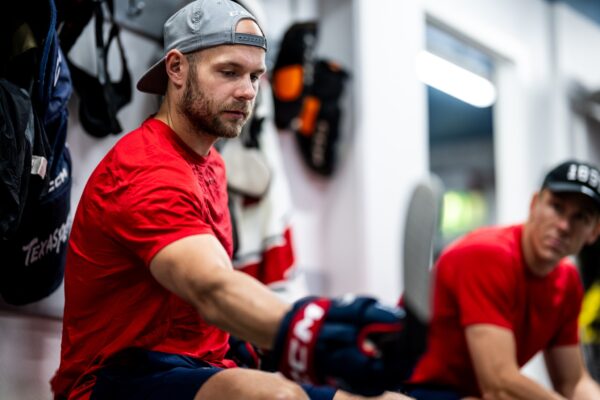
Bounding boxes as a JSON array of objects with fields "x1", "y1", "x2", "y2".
[{"x1": 346, "y1": 0, "x2": 428, "y2": 302}]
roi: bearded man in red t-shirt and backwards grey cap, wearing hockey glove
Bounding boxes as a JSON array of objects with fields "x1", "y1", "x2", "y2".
[{"x1": 51, "y1": 0, "x2": 412, "y2": 400}]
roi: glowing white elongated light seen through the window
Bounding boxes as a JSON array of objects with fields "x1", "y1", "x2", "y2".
[{"x1": 416, "y1": 51, "x2": 496, "y2": 107}]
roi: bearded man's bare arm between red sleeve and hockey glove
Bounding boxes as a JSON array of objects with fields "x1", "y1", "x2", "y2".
[{"x1": 150, "y1": 235, "x2": 290, "y2": 348}]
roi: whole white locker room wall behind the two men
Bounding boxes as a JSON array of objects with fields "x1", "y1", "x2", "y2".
[{"x1": 0, "y1": 0, "x2": 600, "y2": 400}]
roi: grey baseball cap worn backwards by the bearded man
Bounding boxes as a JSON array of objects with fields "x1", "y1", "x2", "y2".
[{"x1": 137, "y1": 0, "x2": 267, "y2": 95}]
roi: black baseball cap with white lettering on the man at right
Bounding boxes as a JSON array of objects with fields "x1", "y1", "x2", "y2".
[{"x1": 542, "y1": 160, "x2": 600, "y2": 209}]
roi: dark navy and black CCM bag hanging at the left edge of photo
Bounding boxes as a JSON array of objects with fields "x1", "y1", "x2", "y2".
[{"x1": 0, "y1": 0, "x2": 72, "y2": 305}]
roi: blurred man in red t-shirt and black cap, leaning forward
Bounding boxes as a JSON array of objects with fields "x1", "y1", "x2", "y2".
[{"x1": 409, "y1": 160, "x2": 600, "y2": 400}]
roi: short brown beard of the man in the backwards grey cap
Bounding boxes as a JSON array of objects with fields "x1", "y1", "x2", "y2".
[{"x1": 178, "y1": 71, "x2": 251, "y2": 139}]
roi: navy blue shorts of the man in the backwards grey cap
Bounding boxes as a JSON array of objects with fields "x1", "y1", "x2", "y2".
[{"x1": 91, "y1": 348, "x2": 336, "y2": 400}]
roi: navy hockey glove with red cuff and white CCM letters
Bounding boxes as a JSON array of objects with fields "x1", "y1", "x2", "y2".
[{"x1": 263, "y1": 297, "x2": 411, "y2": 396}]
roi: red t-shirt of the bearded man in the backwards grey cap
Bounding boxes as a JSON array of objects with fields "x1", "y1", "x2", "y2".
[{"x1": 52, "y1": 118, "x2": 234, "y2": 399}]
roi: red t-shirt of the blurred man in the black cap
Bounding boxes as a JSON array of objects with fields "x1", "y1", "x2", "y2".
[{"x1": 410, "y1": 225, "x2": 583, "y2": 396}]
